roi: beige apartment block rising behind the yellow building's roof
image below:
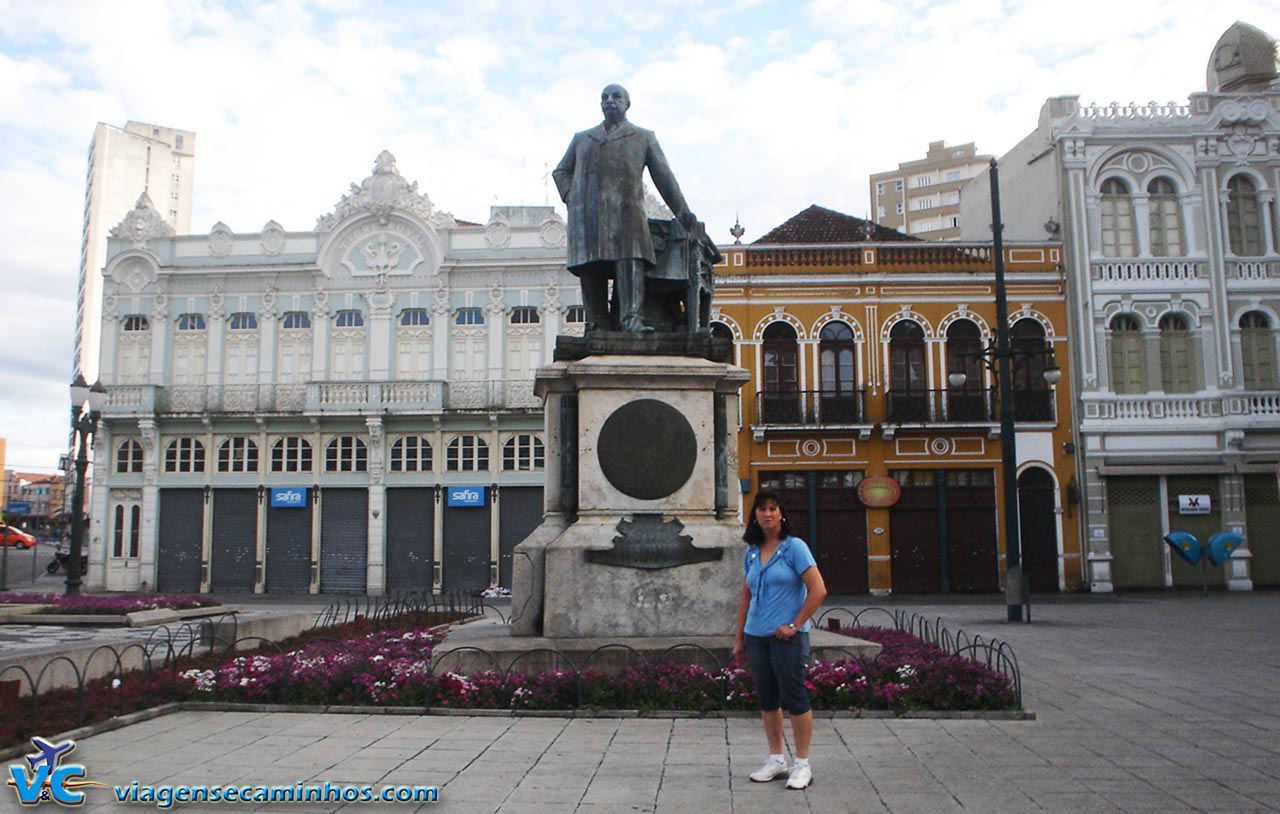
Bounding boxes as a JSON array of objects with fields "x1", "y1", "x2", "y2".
[{"x1": 870, "y1": 141, "x2": 991, "y2": 241}]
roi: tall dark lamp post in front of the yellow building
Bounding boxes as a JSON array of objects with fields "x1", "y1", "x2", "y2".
[{"x1": 947, "y1": 159, "x2": 1062, "y2": 622}]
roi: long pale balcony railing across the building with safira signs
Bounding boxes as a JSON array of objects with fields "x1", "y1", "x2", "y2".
[{"x1": 102, "y1": 379, "x2": 541, "y2": 416}]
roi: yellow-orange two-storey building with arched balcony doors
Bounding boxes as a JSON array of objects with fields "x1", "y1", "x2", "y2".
[{"x1": 712, "y1": 206, "x2": 1082, "y2": 594}]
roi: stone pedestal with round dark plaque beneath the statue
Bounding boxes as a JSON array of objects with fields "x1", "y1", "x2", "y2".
[{"x1": 511, "y1": 351, "x2": 748, "y2": 640}]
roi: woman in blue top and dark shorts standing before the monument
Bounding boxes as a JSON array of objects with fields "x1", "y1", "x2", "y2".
[{"x1": 733, "y1": 490, "x2": 827, "y2": 788}]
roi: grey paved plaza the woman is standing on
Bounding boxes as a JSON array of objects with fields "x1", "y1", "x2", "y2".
[{"x1": 0, "y1": 593, "x2": 1280, "y2": 814}]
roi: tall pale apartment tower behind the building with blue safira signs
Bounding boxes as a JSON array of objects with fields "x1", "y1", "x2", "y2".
[{"x1": 72, "y1": 122, "x2": 196, "y2": 381}]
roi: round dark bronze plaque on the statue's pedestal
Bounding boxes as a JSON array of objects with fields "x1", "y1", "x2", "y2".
[{"x1": 595, "y1": 398, "x2": 698, "y2": 500}]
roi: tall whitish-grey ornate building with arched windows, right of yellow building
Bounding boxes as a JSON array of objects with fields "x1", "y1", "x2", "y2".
[{"x1": 961, "y1": 23, "x2": 1280, "y2": 591}]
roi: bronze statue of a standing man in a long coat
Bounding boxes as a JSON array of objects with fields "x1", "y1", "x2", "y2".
[{"x1": 552, "y1": 84, "x2": 698, "y2": 333}]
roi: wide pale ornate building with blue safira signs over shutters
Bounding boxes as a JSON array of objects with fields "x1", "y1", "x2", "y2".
[{"x1": 88, "y1": 152, "x2": 582, "y2": 594}]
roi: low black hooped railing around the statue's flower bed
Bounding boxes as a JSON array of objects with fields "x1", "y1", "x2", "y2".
[{"x1": 0, "y1": 594, "x2": 1023, "y2": 760}]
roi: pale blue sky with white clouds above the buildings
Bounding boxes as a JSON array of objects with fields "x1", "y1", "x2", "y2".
[{"x1": 0, "y1": 0, "x2": 1280, "y2": 472}]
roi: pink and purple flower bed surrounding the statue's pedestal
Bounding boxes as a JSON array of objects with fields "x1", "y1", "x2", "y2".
[{"x1": 182, "y1": 627, "x2": 1018, "y2": 712}]
